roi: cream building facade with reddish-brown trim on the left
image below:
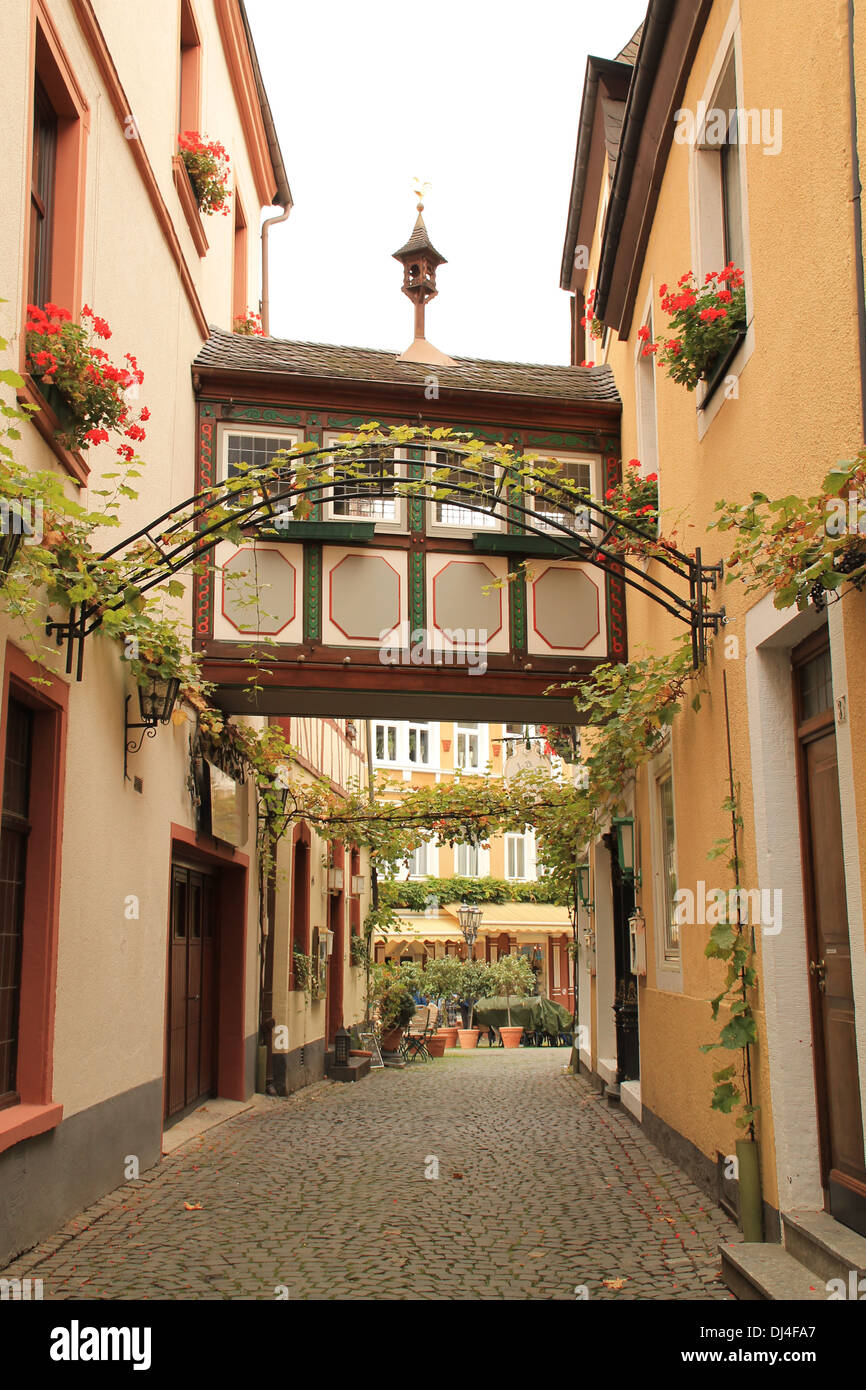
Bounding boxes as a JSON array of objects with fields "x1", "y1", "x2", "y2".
[{"x1": 0, "y1": 0, "x2": 363, "y2": 1261}]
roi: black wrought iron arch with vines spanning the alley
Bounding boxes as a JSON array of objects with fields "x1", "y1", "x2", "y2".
[{"x1": 46, "y1": 435, "x2": 726, "y2": 680}]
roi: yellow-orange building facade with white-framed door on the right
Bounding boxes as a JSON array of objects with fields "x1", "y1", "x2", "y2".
[{"x1": 562, "y1": 0, "x2": 866, "y2": 1238}]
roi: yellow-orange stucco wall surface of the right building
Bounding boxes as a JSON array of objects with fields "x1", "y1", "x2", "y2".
[{"x1": 575, "y1": 0, "x2": 866, "y2": 1205}]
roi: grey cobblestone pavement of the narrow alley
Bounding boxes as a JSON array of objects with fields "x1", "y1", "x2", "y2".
[{"x1": 4, "y1": 1048, "x2": 735, "y2": 1300}]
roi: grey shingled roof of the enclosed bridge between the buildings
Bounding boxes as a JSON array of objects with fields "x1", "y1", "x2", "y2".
[{"x1": 193, "y1": 328, "x2": 620, "y2": 406}]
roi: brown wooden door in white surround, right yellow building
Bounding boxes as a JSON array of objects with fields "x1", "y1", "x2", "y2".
[{"x1": 795, "y1": 639, "x2": 866, "y2": 1234}]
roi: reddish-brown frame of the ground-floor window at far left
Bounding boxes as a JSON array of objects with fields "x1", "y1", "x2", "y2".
[{"x1": 0, "y1": 642, "x2": 68, "y2": 1151}]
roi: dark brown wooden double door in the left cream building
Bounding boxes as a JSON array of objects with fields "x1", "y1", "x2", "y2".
[{"x1": 165, "y1": 865, "x2": 217, "y2": 1119}]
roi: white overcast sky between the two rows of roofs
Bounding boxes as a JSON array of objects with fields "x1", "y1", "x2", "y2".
[{"x1": 244, "y1": 0, "x2": 646, "y2": 363}]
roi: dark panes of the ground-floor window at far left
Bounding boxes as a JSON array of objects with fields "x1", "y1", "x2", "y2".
[{"x1": 0, "y1": 698, "x2": 33, "y2": 1108}]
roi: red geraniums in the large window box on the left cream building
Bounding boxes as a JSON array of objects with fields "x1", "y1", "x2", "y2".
[{"x1": 25, "y1": 304, "x2": 150, "y2": 463}]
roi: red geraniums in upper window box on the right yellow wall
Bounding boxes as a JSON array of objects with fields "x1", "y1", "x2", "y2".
[{"x1": 647, "y1": 261, "x2": 746, "y2": 391}]
